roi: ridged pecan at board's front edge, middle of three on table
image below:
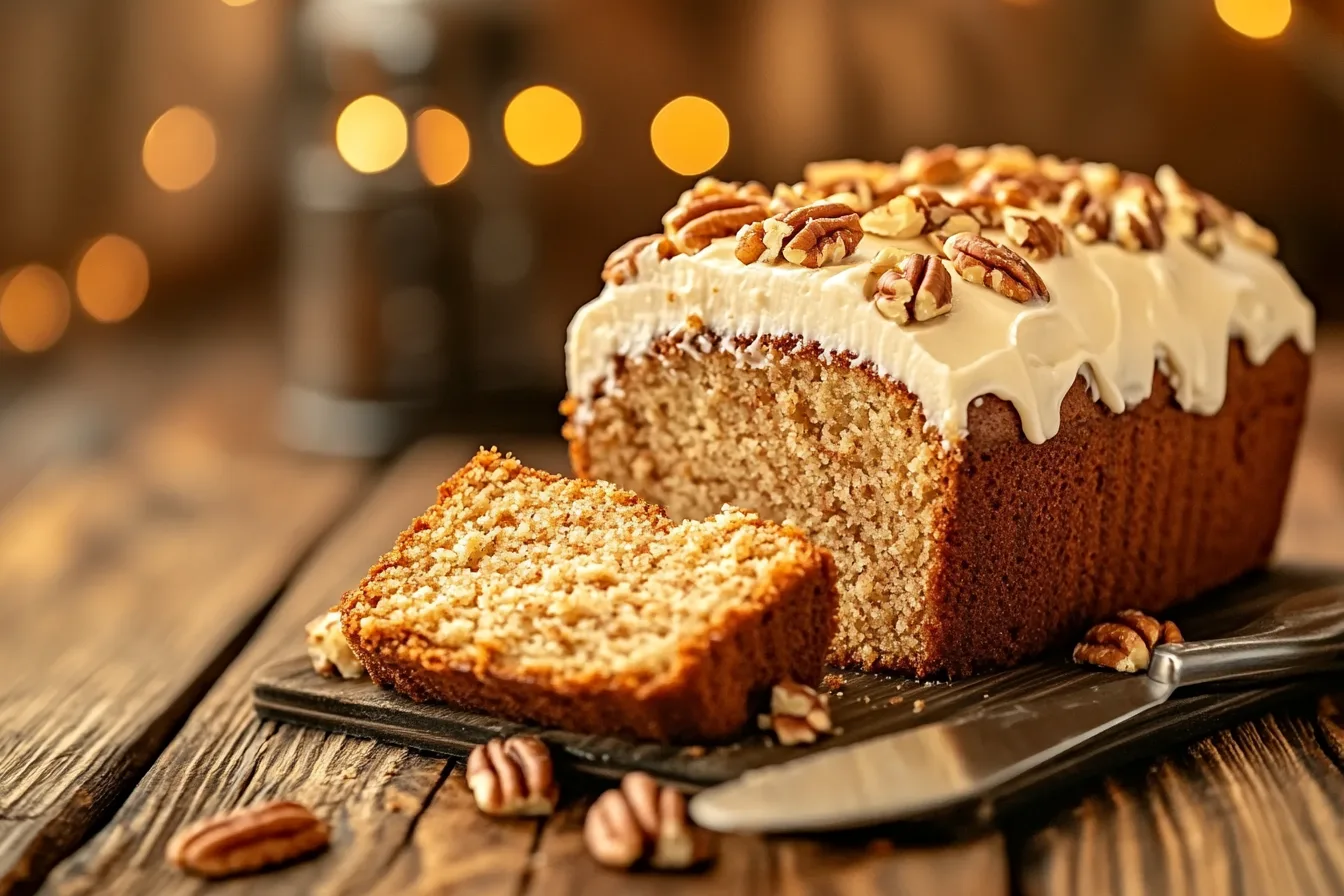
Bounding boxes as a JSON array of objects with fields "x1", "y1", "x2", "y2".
[{"x1": 466, "y1": 737, "x2": 560, "y2": 815}]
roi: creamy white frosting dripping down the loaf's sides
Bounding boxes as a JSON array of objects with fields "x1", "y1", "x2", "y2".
[{"x1": 566, "y1": 208, "x2": 1314, "y2": 442}]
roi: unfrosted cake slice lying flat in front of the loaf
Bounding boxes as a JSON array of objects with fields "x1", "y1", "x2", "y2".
[{"x1": 340, "y1": 450, "x2": 837, "y2": 742}]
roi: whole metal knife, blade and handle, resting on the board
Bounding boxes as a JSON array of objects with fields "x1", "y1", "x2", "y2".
[{"x1": 691, "y1": 584, "x2": 1344, "y2": 833}]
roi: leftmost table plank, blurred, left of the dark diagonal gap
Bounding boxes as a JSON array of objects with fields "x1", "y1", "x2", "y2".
[{"x1": 0, "y1": 338, "x2": 363, "y2": 892}]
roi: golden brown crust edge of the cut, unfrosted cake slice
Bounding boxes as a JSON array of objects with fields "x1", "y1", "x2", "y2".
[{"x1": 340, "y1": 450, "x2": 836, "y2": 742}]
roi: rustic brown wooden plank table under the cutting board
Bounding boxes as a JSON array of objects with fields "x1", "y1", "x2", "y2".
[{"x1": 0, "y1": 318, "x2": 1344, "y2": 896}]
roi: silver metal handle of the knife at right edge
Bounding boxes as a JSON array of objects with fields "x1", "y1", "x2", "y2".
[{"x1": 1148, "y1": 586, "x2": 1344, "y2": 686}]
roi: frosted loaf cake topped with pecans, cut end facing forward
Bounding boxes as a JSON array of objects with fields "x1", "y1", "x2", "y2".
[{"x1": 562, "y1": 145, "x2": 1313, "y2": 677}]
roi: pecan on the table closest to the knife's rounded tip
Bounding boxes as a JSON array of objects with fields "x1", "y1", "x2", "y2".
[{"x1": 583, "y1": 771, "x2": 712, "y2": 869}]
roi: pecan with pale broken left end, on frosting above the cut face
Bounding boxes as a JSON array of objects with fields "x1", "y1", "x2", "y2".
[{"x1": 737, "y1": 201, "x2": 863, "y2": 267}]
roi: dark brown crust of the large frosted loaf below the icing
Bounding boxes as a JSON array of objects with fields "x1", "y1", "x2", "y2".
[{"x1": 566, "y1": 334, "x2": 1309, "y2": 677}]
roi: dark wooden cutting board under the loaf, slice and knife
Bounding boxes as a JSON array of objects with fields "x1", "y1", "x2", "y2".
[{"x1": 253, "y1": 568, "x2": 1344, "y2": 821}]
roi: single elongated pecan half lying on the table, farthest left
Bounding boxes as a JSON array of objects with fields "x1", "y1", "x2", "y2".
[{"x1": 168, "y1": 802, "x2": 328, "y2": 877}]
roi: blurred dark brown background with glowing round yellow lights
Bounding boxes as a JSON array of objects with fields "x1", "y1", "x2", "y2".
[{"x1": 0, "y1": 0, "x2": 1344, "y2": 454}]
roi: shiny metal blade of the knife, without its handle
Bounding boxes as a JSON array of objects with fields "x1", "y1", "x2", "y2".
[{"x1": 689, "y1": 676, "x2": 1176, "y2": 833}]
